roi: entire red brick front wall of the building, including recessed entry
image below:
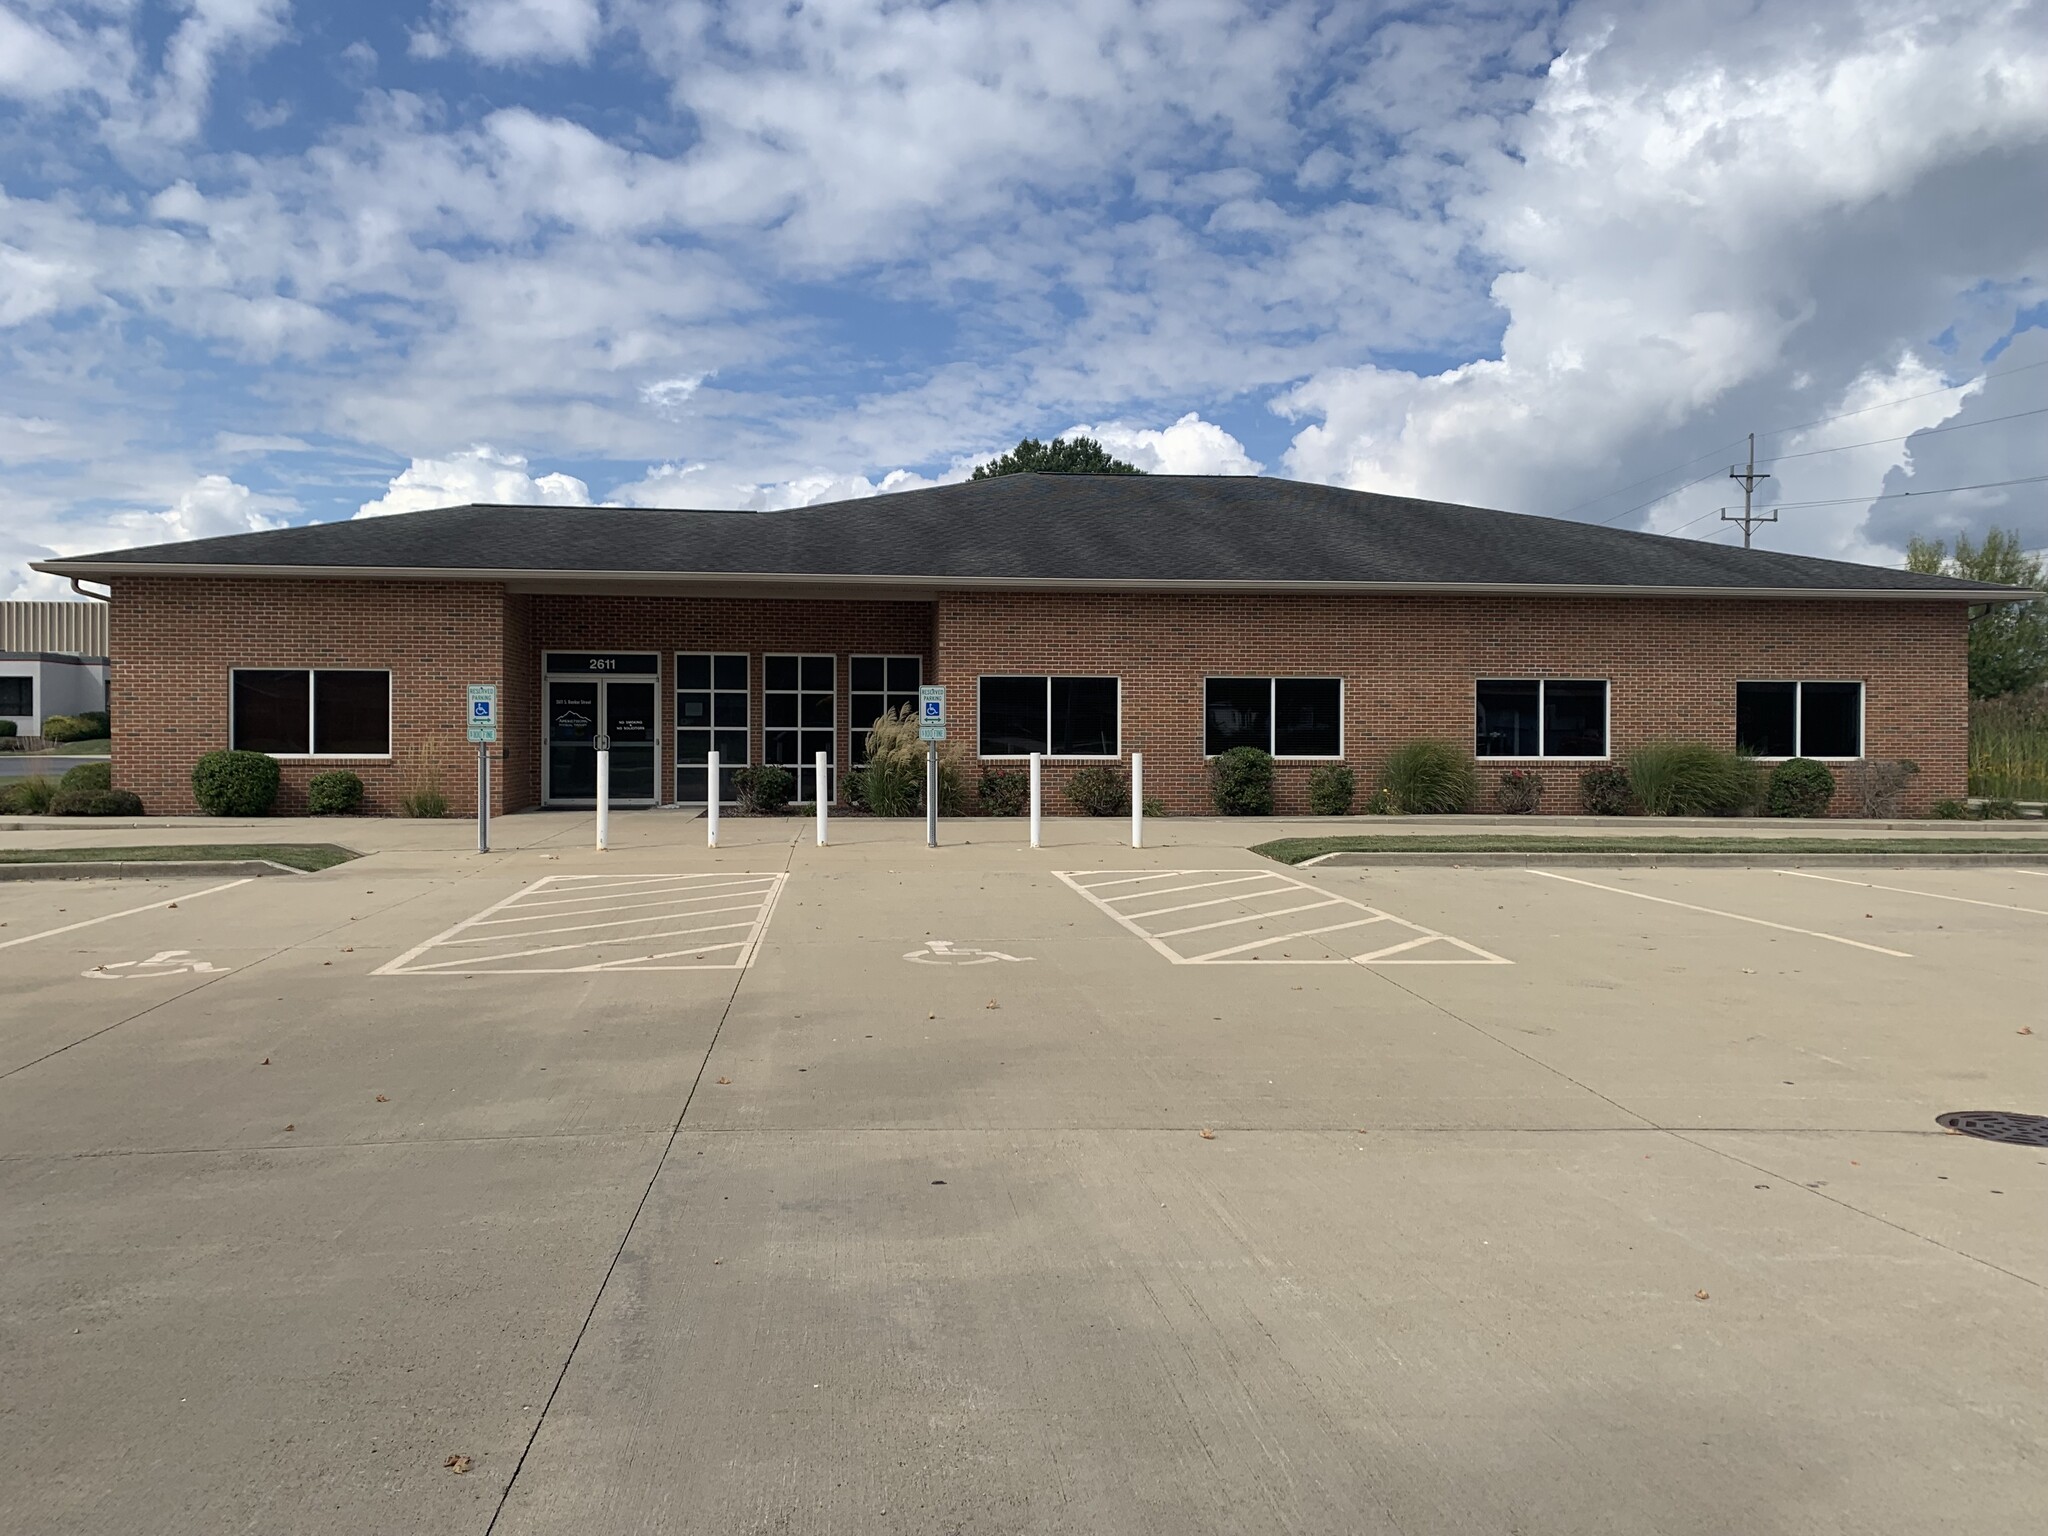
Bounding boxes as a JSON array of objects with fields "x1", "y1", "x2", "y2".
[{"x1": 111, "y1": 575, "x2": 1968, "y2": 815}]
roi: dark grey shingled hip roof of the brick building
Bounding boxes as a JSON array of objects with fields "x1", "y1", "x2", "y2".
[{"x1": 37, "y1": 475, "x2": 2011, "y2": 598}]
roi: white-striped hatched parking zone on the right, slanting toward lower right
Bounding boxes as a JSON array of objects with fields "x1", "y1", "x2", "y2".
[{"x1": 1053, "y1": 868, "x2": 1513, "y2": 965}]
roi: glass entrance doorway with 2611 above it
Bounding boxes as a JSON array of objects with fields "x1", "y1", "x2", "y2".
[{"x1": 541, "y1": 651, "x2": 662, "y2": 805}]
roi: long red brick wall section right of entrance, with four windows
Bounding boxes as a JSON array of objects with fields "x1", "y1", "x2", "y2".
[{"x1": 936, "y1": 592, "x2": 1968, "y2": 813}]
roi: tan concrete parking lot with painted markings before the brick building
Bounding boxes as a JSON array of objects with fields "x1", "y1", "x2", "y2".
[{"x1": 0, "y1": 813, "x2": 2048, "y2": 1536}]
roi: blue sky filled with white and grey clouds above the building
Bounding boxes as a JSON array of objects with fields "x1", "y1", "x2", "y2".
[{"x1": 0, "y1": 0, "x2": 2048, "y2": 594}]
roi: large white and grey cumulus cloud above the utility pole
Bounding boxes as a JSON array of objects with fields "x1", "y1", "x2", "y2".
[{"x1": 1276, "y1": 4, "x2": 2048, "y2": 557}]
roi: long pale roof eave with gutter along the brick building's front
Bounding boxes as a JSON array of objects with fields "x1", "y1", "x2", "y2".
[{"x1": 29, "y1": 559, "x2": 2044, "y2": 602}]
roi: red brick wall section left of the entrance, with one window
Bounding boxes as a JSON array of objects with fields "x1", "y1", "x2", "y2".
[{"x1": 109, "y1": 575, "x2": 504, "y2": 815}]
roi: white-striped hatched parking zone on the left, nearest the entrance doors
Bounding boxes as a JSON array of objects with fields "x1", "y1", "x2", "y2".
[{"x1": 371, "y1": 874, "x2": 788, "y2": 977}]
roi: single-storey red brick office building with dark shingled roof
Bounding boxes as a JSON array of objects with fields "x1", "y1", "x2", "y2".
[{"x1": 37, "y1": 475, "x2": 2019, "y2": 813}]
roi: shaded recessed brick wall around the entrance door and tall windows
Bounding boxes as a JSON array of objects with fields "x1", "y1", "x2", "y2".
[{"x1": 506, "y1": 596, "x2": 932, "y2": 805}]
